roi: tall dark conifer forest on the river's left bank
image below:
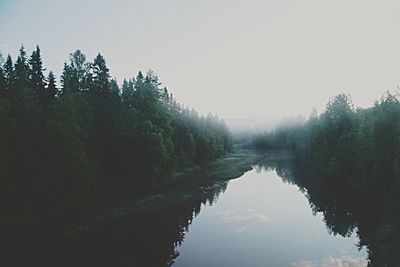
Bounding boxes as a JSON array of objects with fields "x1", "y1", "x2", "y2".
[{"x1": 0, "y1": 47, "x2": 232, "y2": 230}]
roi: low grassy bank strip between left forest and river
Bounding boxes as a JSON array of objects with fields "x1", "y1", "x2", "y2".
[{"x1": 73, "y1": 150, "x2": 264, "y2": 232}]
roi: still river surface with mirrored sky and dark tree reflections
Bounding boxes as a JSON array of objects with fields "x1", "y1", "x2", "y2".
[{"x1": 7, "y1": 153, "x2": 370, "y2": 267}]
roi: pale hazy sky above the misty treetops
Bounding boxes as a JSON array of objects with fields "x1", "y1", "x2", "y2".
[{"x1": 0, "y1": 0, "x2": 400, "y2": 119}]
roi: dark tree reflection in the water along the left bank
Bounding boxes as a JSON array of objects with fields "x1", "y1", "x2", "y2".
[{"x1": 2, "y1": 181, "x2": 227, "y2": 266}]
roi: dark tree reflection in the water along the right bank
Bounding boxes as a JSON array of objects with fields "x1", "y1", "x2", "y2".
[{"x1": 255, "y1": 152, "x2": 400, "y2": 267}]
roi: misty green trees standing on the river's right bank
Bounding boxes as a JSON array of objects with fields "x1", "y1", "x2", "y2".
[{"x1": 250, "y1": 93, "x2": 400, "y2": 193}]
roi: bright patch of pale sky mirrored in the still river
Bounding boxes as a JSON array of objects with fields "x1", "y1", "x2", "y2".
[{"x1": 175, "y1": 170, "x2": 367, "y2": 267}]
